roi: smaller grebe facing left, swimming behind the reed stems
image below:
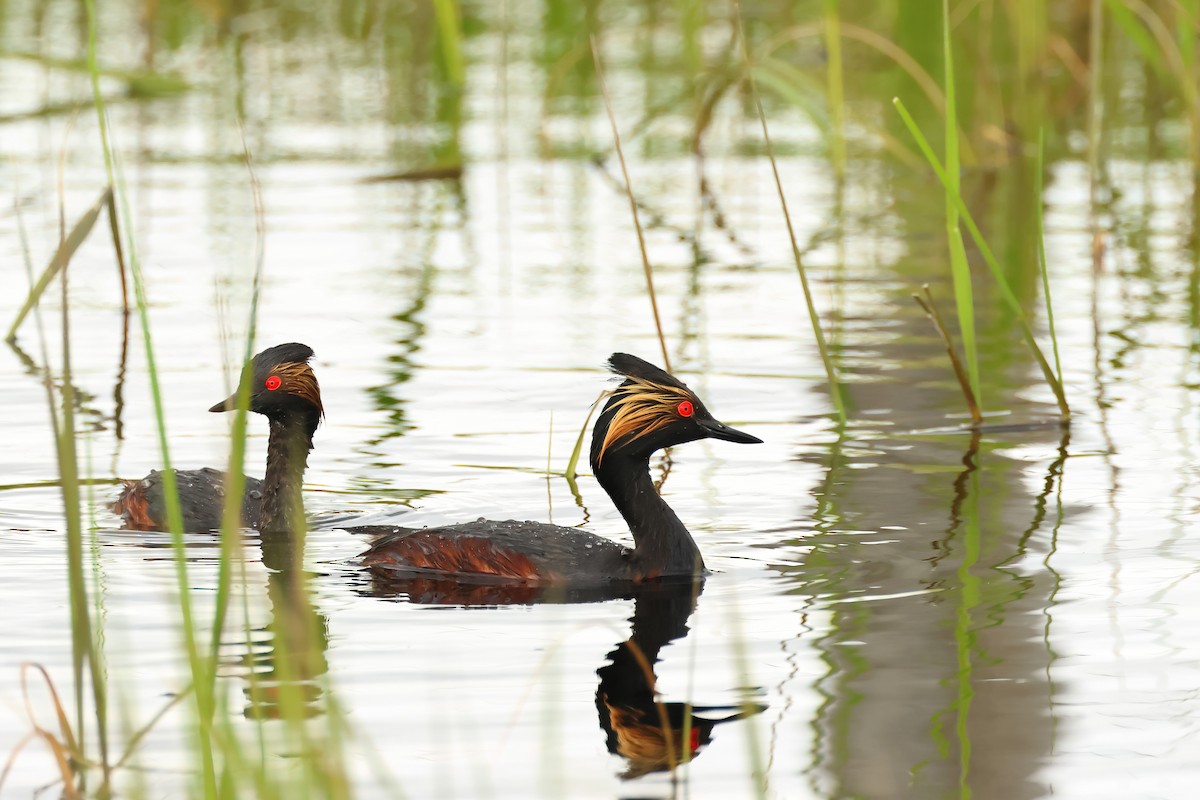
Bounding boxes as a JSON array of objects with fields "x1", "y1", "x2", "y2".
[{"x1": 113, "y1": 342, "x2": 324, "y2": 533}]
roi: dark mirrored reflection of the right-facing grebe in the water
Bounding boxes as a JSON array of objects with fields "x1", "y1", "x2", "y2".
[{"x1": 364, "y1": 576, "x2": 766, "y2": 780}]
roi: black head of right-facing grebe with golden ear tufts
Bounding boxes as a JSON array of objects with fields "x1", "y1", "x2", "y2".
[{"x1": 592, "y1": 353, "x2": 762, "y2": 470}]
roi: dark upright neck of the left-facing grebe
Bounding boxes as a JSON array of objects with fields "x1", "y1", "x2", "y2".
[{"x1": 258, "y1": 411, "x2": 319, "y2": 534}]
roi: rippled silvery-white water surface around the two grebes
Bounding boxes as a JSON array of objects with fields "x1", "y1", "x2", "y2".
[{"x1": 0, "y1": 3, "x2": 1200, "y2": 799}]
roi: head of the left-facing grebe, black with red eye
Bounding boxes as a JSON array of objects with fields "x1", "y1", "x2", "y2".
[{"x1": 209, "y1": 342, "x2": 325, "y2": 434}]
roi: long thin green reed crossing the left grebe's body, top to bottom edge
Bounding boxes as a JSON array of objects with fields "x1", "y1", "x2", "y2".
[{"x1": 84, "y1": 0, "x2": 217, "y2": 798}]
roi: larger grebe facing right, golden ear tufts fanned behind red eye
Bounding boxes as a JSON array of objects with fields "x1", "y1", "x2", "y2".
[{"x1": 360, "y1": 353, "x2": 762, "y2": 585}]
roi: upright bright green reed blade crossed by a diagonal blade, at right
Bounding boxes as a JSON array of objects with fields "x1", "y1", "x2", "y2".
[{"x1": 942, "y1": 0, "x2": 983, "y2": 412}]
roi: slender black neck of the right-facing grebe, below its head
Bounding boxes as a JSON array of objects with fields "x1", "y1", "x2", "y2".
[{"x1": 593, "y1": 452, "x2": 704, "y2": 577}]
